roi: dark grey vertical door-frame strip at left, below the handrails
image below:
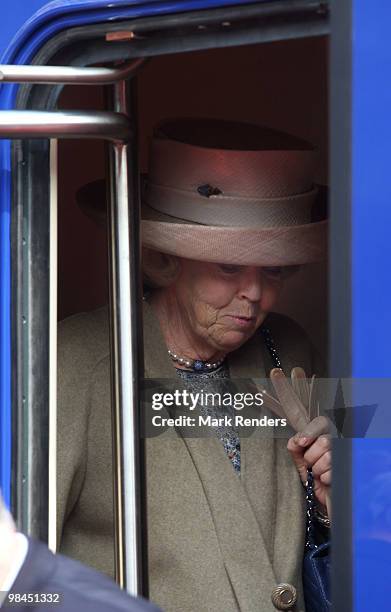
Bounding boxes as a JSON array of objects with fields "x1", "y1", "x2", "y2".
[{"x1": 11, "y1": 141, "x2": 50, "y2": 542}]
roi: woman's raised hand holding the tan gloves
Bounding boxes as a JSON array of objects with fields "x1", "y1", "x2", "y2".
[{"x1": 287, "y1": 416, "x2": 331, "y2": 510}]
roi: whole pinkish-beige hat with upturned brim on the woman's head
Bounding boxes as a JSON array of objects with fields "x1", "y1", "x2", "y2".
[{"x1": 77, "y1": 119, "x2": 327, "y2": 266}]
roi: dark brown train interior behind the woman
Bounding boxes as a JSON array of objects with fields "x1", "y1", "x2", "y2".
[{"x1": 58, "y1": 37, "x2": 328, "y2": 357}]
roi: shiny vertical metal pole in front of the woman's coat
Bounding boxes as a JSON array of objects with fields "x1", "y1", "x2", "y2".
[{"x1": 110, "y1": 81, "x2": 147, "y2": 595}]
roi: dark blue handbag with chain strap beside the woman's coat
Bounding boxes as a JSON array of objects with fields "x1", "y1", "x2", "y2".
[{"x1": 303, "y1": 470, "x2": 331, "y2": 612}]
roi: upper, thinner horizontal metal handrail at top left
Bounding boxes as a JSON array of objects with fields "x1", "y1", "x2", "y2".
[{"x1": 0, "y1": 58, "x2": 146, "y2": 85}]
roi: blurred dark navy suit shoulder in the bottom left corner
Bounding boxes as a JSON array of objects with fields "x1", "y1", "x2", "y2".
[{"x1": 11, "y1": 539, "x2": 158, "y2": 612}]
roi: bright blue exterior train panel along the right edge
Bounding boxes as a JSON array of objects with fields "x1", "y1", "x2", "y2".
[{"x1": 352, "y1": 0, "x2": 391, "y2": 612}]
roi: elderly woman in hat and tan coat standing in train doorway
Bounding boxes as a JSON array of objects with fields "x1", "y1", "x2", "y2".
[{"x1": 58, "y1": 120, "x2": 331, "y2": 612}]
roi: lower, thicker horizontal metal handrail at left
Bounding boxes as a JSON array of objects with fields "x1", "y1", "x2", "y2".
[{"x1": 0, "y1": 111, "x2": 132, "y2": 143}]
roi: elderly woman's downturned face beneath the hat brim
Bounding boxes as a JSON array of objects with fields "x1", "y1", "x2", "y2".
[{"x1": 173, "y1": 259, "x2": 282, "y2": 352}]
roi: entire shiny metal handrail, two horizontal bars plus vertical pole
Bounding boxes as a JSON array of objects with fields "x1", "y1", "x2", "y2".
[{"x1": 0, "y1": 51, "x2": 147, "y2": 595}]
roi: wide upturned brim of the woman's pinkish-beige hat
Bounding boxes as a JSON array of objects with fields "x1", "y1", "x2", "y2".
[{"x1": 76, "y1": 181, "x2": 328, "y2": 266}]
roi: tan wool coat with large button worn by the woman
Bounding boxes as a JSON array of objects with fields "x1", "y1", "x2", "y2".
[{"x1": 58, "y1": 305, "x2": 322, "y2": 612}]
